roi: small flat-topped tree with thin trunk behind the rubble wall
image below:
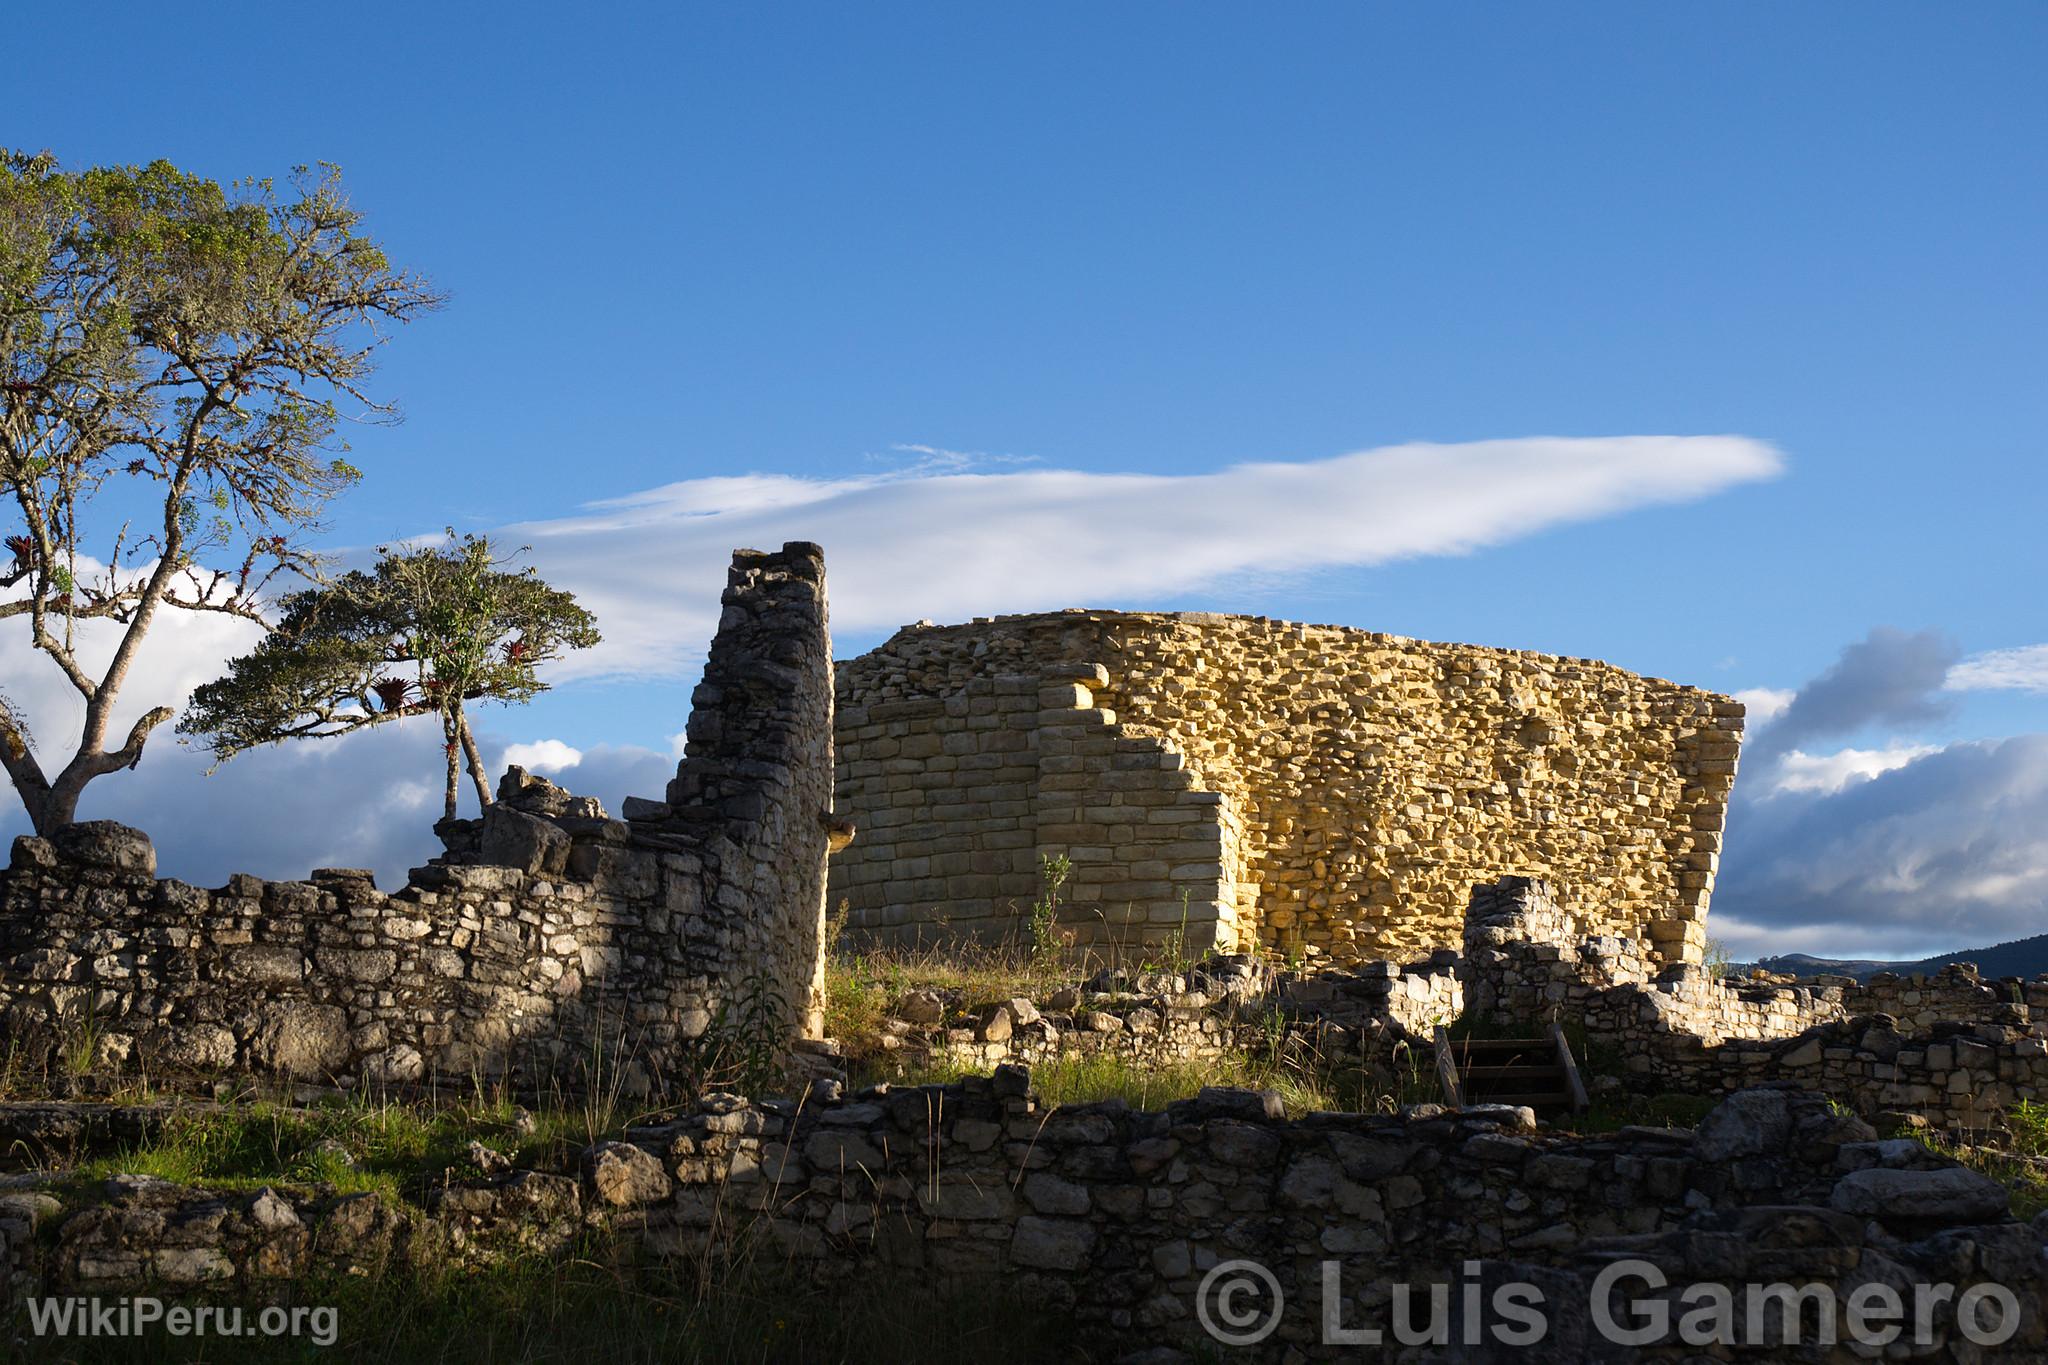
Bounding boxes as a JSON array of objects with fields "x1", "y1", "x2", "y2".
[{"x1": 178, "y1": 530, "x2": 600, "y2": 819}]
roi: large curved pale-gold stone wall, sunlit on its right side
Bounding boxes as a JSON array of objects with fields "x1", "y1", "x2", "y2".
[{"x1": 831, "y1": 612, "x2": 1743, "y2": 964}]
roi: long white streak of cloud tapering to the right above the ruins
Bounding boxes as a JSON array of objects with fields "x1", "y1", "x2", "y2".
[{"x1": 502, "y1": 436, "x2": 1782, "y2": 677}]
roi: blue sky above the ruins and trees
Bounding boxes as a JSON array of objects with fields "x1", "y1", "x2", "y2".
[{"x1": 0, "y1": 4, "x2": 2048, "y2": 952}]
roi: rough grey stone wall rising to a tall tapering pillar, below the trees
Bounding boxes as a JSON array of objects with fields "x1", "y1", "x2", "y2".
[{"x1": 0, "y1": 544, "x2": 831, "y2": 1093}]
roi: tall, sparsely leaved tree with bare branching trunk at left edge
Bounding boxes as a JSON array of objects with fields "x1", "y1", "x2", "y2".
[{"x1": 0, "y1": 151, "x2": 438, "y2": 835}]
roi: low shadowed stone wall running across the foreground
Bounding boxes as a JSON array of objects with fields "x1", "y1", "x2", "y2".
[{"x1": 12, "y1": 1068, "x2": 2048, "y2": 1365}]
